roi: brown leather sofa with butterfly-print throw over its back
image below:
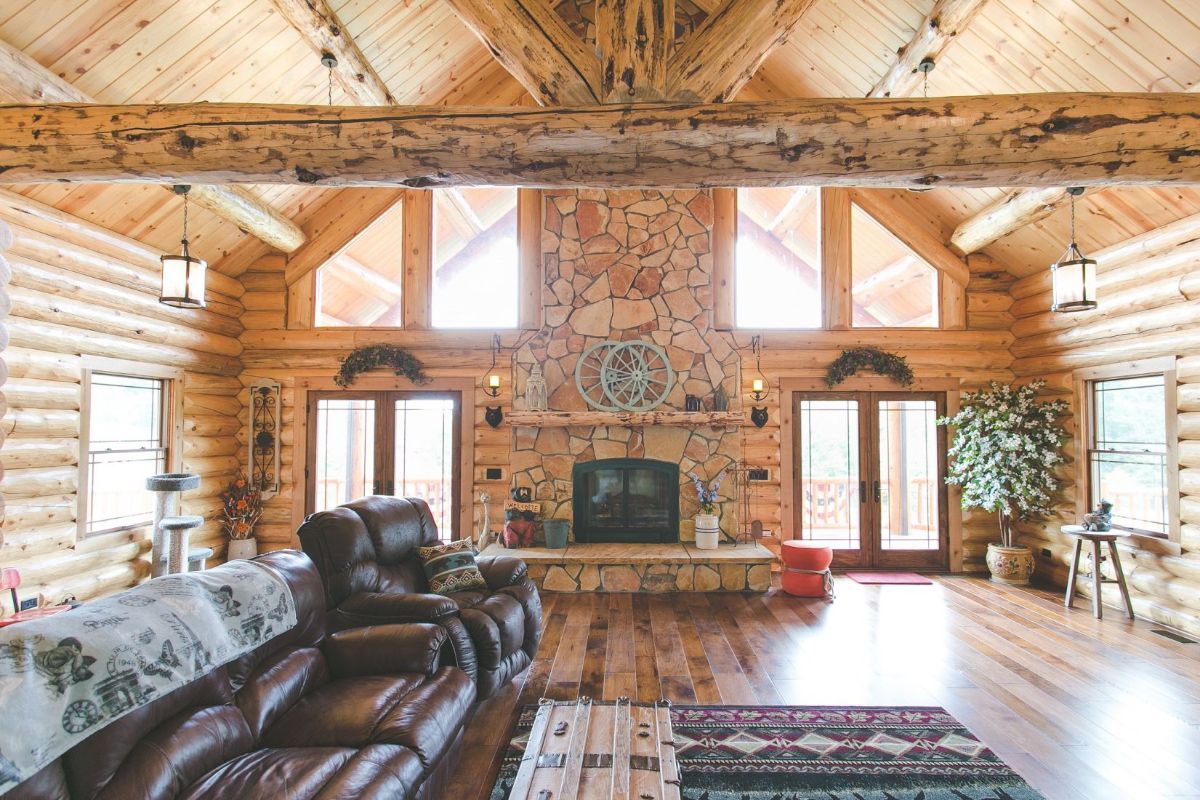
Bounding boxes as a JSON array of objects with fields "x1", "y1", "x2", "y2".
[{"x1": 5, "y1": 551, "x2": 475, "y2": 800}]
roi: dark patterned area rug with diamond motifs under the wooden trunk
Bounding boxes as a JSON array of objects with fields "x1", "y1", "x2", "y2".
[{"x1": 491, "y1": 705, "x2": 1043, "y2": 800}]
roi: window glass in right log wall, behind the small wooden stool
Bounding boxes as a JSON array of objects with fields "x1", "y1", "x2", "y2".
[{"x1": 1087, "y1": 374, "x2": 1172, "y2": 537}]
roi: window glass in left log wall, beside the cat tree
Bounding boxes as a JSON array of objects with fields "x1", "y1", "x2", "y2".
[{"x1": 83, "y1": 372, "x2": 170, "y2": 535}]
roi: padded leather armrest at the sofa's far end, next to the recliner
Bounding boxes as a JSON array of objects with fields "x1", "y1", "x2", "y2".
[{"x1": 322, "y1": 622, "x2": 449, "y2": 678}]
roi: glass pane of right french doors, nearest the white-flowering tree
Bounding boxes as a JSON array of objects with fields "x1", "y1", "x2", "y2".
[{"x1": 877, "y1": 399, "x2": 941, "y2": 551}]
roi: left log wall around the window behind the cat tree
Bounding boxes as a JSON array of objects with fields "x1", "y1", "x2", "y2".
[{"x1": 0, "y1": 191, "x2": 242, "y2": 601}]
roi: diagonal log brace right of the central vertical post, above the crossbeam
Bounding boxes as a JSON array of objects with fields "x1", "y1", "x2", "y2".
[{"x1": 666, "y1": 0, "x2": 815, "y2": 103}]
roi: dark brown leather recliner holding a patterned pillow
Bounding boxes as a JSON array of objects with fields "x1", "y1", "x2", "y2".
[{"x1": 300, "y1": 497, "x2": 541, "y2": 699}]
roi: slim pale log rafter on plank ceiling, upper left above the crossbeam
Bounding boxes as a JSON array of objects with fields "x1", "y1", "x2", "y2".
[{"x1": 272, "y1": 0, "x2": 396, "y2": 106}]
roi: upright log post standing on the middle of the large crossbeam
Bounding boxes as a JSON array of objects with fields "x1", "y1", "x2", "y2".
[{"x1": 595, "y1": 0, "x2": 674, "y2": 103}]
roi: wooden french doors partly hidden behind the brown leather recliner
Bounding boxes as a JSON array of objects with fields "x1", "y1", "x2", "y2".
[{"x1": 305, "y1": 391, "x2": 462, "y2": 540}]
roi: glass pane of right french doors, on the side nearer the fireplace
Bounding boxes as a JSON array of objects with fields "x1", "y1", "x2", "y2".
[{"x1": 799, "y1": 399, "x2": 862, "y2": 549}]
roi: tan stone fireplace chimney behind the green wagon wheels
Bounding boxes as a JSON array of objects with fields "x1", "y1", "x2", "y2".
[{"x1": 510, "y1": 190, "x2": 742, "y2": 543}]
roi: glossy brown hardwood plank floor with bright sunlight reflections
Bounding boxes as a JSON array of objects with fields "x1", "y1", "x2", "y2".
[{"x1": 445, "y1": 577, "x2": 1200, "y2": 800}]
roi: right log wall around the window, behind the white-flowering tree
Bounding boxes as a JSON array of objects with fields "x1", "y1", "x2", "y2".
[{"x1": 1012, "y1": 221, "x2": 1200, "y2": 634}]
